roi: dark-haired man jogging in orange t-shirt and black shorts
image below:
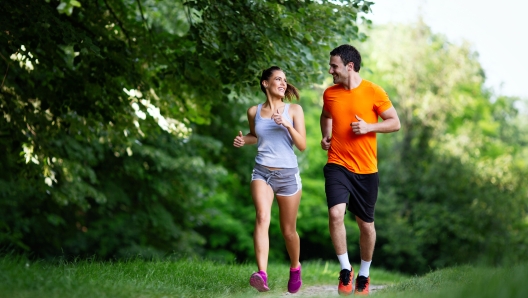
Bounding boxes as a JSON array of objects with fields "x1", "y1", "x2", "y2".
[{"x1": 320, "y1": 45, "x2": 400, "y2": 295}]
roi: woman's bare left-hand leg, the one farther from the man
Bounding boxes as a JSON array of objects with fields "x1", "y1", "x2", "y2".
[{"x1": 251, "y1": 180, "x2": 273, "y2": 272}]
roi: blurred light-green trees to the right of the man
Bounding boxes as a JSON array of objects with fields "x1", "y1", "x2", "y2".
[{"x1": 363, "y1": 23, "x2": 528, "y2": 272}]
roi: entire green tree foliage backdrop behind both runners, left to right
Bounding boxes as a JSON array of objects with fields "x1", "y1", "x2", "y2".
[{"x1": 0, "y1": 0, "x2": 528, "y2": 273}]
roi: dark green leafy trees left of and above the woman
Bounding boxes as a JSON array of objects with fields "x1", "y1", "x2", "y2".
[{"x1": 0, "y1": 0, "x2": 371, "y2": 259}]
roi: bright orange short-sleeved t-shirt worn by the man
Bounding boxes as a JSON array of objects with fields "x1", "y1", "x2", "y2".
[{"x1": 323, "y1": 80, "x2": 392, "y2": 174}]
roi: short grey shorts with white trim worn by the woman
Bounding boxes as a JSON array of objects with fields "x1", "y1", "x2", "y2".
[{"x1": 251, "y1": 164, "x2": 302, "y2": 197}]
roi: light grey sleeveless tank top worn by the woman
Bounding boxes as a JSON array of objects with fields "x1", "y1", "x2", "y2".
[{"x1": 255, "y1": 104, "x2": 297, "y2": 169}]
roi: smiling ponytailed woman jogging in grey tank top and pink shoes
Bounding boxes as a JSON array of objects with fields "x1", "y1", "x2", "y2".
[{"x1": 233, "y1": 66, "x2": 306, "y2": 293}]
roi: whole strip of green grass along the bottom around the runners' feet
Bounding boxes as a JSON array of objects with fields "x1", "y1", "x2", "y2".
[{"x1": 0, "y1": 256, "x2": 528, "y2": 298}]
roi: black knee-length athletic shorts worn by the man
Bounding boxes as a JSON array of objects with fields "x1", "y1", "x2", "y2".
[{"x1": 323, "y1": 163, "x2": 379, "y2": 222}]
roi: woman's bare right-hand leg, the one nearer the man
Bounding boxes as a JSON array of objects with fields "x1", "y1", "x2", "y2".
[{"x1": 277, "y1": 190, "x2": 302, "y2": 268}]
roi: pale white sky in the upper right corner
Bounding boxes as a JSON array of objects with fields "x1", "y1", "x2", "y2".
[{"x1": 368, "y1": 0, "x2": 528, "y2": 98}]
